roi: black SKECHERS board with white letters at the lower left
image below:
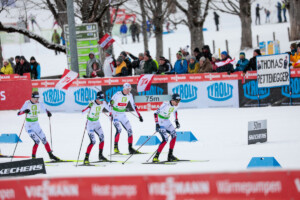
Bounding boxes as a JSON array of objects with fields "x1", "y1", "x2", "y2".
[{"x1": 0, "y1": 158, "x2": 46, "y2": 177}]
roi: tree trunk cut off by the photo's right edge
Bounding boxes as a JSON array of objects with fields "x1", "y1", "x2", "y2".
[{"x1": 287, "y1": 0, "x2": 300, "y2": 40}]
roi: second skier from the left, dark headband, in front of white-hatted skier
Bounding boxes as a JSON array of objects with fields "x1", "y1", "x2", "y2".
[{"x1": 82, "y1": 91, "x2": 111, "y2": 164}]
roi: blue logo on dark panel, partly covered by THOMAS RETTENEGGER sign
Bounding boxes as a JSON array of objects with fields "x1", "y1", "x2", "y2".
[{"x1": 243, "y1": 80, "x2": 270, "y2": 100}]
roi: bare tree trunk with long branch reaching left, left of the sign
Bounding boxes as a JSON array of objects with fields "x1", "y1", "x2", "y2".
[{"x1": 212, "y1": 0, "x2": 253, "y2": 49}]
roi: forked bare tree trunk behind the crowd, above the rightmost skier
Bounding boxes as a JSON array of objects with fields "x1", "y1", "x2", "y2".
[{"x1": 174, "y1": 0, "x2": 210, "y2": 50}]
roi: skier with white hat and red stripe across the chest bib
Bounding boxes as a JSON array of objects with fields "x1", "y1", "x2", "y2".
[{"x1": 110, "y1": 83, "x2": 143, "y2": 154}]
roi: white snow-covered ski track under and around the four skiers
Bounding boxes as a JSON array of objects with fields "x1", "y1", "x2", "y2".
[{"x1": 0, "y1": 106, "x2": 300, "y2": 177}]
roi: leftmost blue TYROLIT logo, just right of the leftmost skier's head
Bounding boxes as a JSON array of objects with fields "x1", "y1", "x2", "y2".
[{"x1": 43, "y1": 89, "x2": 66, "y2": 106}]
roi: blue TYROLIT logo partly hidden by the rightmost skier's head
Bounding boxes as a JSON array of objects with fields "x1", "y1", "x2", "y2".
[{"x1": 172, "y1": 84, "x2": 198, "y2": 103}]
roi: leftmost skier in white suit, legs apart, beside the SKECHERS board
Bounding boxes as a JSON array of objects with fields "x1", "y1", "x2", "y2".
[{"x1": 18, "y1": 91, "x2": 60, "y2": 161}]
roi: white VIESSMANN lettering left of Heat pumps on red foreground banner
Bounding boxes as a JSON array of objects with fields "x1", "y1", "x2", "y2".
[{"x1": 25, "y1": 181, "x2": 79, "y2": 200}]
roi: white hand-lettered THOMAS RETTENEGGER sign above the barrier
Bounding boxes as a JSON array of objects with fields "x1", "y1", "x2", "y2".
[{"x1": 256, "y1": 54, "x2": 290, "y2": 88}]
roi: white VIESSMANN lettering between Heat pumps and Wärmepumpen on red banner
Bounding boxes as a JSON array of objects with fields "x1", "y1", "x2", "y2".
[{"x1": 148, "y1": 177, "x2": 210, "y2": 200}]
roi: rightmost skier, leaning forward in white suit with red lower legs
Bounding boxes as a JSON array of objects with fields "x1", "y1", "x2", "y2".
[{"x1": 153, "y1": 94, "x2": 181, "y2": 162}]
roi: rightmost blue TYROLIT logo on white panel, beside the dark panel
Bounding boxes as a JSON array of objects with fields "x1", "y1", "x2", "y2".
[{"x1": 207, "y1": 82, "x2": 233, "y2": 101}]
